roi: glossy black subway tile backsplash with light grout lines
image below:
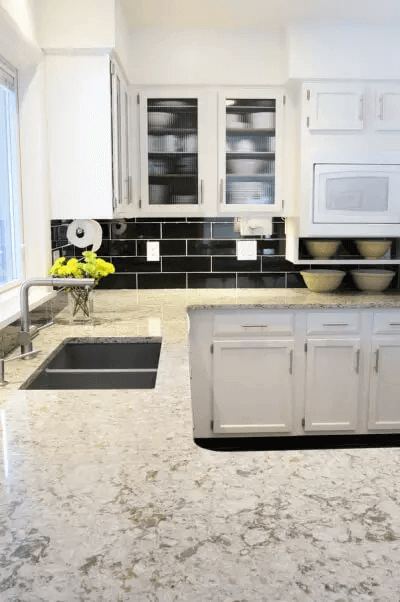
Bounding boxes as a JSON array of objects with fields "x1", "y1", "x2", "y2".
[{"x1": 51, "y1": 216, "x2": 400, "y2": 290}]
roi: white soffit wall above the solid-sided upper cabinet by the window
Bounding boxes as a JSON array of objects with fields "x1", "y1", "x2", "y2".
[{"x1": 34, "y1": 0, "x2": 115, "y2": 48}]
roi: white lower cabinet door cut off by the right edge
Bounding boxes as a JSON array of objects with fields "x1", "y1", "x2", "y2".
[{"x1": 368, "y1": 337, "x2": 400, "y2": 430}]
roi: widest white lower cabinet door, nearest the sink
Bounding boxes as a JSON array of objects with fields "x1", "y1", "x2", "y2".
[{"x1": 213, "y1": 340, "x2": 294, "y2": 434}]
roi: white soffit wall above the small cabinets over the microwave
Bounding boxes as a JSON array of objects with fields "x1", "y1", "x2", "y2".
[{"x1": 287, "y1": 22, "x2": 400, "y2": 80}]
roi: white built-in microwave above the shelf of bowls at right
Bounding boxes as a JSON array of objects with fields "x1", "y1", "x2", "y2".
[{"x1": 313, "y1": 163, "x2": 400, "y2": 224}]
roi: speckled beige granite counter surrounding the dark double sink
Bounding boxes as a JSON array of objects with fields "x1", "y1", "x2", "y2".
[{"x1": 0, "y1": 290, "x2": 400, "y2": 602}]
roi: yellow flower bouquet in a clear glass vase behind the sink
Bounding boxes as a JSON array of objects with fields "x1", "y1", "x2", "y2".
[{"x1": 49, "y1": 251, "x2": 115, "y2": 319}]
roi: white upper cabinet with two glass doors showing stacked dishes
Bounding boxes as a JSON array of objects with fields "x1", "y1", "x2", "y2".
[{"x1": 136, "y1": 88, "x2": 283, "y2": 216}]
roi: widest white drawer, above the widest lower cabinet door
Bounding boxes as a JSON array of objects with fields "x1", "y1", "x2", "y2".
[{"x1": 214, "y1": 310, "x2": 294, "y2": 336}]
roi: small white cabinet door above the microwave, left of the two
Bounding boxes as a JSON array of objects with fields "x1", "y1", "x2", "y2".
[{"x1": 305, "y1": 83, "x2": 364, "y2": 131}]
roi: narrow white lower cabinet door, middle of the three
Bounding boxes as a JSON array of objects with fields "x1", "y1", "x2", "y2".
[{"x1": 304, "y1": 339, "x2": 360, "y2": 431}]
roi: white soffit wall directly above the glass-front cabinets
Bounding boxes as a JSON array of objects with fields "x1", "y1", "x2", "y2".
[{"x1": 128, "y1": 28, "x2": 285, "y2": 85}]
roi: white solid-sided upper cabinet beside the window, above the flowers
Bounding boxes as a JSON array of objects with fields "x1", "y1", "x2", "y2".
[{"x1": 45, "y1": 54, "x2": 130, "y2": 219}]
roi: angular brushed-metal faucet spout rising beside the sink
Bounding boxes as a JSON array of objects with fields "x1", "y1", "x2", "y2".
[{"x1": 20, "y1": 278, "x2": 96, "y2": 354}]
